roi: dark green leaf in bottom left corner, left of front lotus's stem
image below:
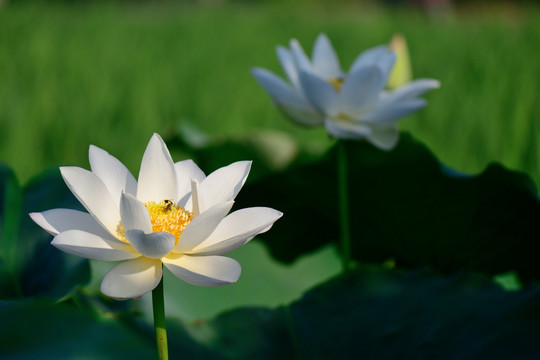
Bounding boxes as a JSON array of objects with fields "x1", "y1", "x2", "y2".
[{"x1": 0, "y1": 299, "x2": 156, "y2": 359}]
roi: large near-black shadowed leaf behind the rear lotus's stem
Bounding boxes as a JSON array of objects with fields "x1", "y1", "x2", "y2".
[{"x1": 237, "y1": 135, "x2": 540, "y2": 280}]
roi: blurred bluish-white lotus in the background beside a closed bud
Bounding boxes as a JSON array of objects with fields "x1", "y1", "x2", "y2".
[{"x1": 252, "y1": 34, "x2": 440, "y2": 150}]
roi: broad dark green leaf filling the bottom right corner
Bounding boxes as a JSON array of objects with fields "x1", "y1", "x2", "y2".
[{"x1": 199, "y1": 265, "x2": 540, "y2": 360}]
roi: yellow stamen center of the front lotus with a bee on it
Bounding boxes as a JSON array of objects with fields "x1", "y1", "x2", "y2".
[{"x1": 144, "y1": 200, "x2": 193, "y2": 243}]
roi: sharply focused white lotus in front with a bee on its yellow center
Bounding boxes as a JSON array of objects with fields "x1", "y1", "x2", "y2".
[{"x1": 30, "y1": 134, "x2": 282, "y2": 299}]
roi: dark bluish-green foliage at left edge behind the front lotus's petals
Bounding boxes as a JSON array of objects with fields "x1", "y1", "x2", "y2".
[{"x1": 0, "y1": 165, "x2": 90, "y2": 299}]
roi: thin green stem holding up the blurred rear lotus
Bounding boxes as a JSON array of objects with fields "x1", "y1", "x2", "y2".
[{"x1": 337, "y1": 140, "x2": 351, "y2": 272}]
